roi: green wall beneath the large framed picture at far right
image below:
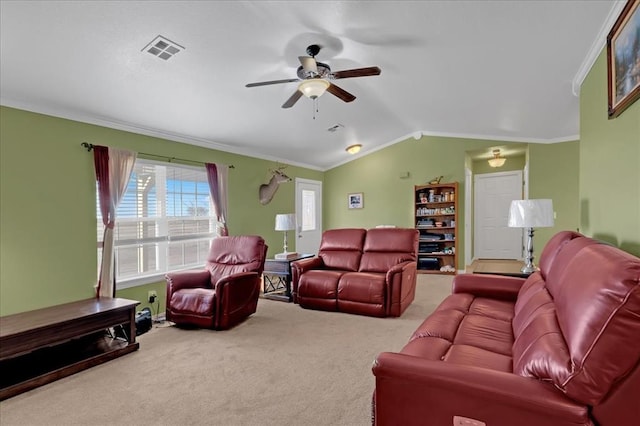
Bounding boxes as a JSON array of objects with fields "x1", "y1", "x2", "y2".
[{"x1": 579, "y1": 50, "x2": 640, "y2": 256}]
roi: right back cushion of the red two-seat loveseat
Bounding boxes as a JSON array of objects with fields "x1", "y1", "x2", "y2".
[{"x1": 359, "y1": 228, "x2": 419, "y2": 272}]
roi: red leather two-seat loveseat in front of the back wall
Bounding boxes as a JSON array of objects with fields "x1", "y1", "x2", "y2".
[{"x1": 291, "y1": 228, "x2": 418, "y2": 317}]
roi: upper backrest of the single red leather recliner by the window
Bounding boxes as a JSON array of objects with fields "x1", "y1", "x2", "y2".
[{"x1": 205, "y1": 235, "x2": 267, "y2": 285}]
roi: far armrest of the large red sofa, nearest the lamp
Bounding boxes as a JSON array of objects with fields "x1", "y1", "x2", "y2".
[{"x1": 452, "y1": 274, "x2": 526, "y2": 300}]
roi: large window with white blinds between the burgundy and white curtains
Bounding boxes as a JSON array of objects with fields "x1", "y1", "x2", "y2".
[{"x1": 96, "y1": 159, "x2": 217, "y2": 288}]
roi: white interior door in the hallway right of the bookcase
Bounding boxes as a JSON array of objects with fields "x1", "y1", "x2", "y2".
[{"x1": 473, "y1": 170, "x2": 522, "y2": 259}]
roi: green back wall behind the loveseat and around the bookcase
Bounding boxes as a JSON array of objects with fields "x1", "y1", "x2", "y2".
[{"x1": 324, "y1": 136, "x2": 578, "y2": 269}]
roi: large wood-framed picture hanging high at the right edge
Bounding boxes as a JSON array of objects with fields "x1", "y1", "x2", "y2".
[{"x1": 607, "y1": 0, "x2": 640, "y2": 118}]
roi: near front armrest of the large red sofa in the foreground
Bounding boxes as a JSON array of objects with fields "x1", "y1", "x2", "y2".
[{"x1": 373, "y1": 352, "x2": 592, "y2": 426}]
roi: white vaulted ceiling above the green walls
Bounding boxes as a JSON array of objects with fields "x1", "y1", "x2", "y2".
[{"x1": 0, "y1": 0, "x2": 621, "y2": 170}]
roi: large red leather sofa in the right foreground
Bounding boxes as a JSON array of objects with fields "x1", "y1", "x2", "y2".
[{"x1": 373, "y1": 231, "x2": 640, "y2": 426}]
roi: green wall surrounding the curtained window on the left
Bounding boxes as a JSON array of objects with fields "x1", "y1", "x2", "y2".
[{"x1": 0, "y1": 107, "x2": 323, "y2": 315}]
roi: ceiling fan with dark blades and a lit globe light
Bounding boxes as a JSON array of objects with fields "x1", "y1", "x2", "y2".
[{"x1": 246, "y1": 44, "x2": 380, "y2": 108}]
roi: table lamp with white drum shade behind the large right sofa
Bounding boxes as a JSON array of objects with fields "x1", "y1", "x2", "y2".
[{"x1": 509, "y1": 199, "x2": 553, "y2": 274}]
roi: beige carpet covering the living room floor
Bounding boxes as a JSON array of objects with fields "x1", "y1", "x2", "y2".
[{"x1": 0, "y1": 275, "x2": 451, "y2": 426}]
